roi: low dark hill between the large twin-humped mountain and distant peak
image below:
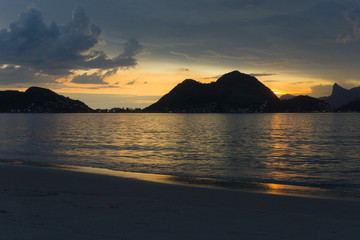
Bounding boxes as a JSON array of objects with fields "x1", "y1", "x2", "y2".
[{"x1": 275, "y1": 96, "x2": 331, "y2": 112}]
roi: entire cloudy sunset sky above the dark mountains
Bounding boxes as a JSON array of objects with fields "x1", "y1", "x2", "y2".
[{"x1": 0, "y1": 0, "x2": 360, "y2": 108}]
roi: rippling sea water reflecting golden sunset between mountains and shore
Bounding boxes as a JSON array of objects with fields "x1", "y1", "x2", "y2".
[{"x1": 0, "y1": 113, "x2": 360, "y2": 198}]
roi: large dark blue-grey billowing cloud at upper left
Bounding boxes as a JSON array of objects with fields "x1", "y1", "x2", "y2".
[{"x1": 0, "y1": 8, "x2": 142, "y2": 82}]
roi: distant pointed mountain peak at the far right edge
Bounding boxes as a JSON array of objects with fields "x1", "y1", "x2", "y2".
[{"x1": 319, "y1": 83, "x2": 360, "y2": 108}]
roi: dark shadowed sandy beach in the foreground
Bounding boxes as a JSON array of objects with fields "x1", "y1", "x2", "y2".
[{"x1": 0, "y1": 164, "x2": 360, "y2": 240}]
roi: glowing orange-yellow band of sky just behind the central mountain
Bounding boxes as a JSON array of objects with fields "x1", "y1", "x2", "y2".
[{"x1": 50, "y1": 61, "x2": 330, "y2": 107}]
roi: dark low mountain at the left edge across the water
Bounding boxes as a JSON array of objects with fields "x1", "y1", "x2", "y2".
[{"x1": 0, "y1": 87, "x2": 93, "y2": 113}]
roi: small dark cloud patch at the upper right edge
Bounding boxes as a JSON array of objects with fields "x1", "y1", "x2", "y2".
[{"x1": 336, "y1": 8, "x2": 360, "y2": 44}]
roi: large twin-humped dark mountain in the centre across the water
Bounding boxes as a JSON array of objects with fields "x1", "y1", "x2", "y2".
[{"x1": 144, "y1": 71, "x2": 279, "y2": 112}]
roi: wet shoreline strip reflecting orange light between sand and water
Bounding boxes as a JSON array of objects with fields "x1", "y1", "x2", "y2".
[{"x1": 0, "y1": 159, "x2": 360, "y2": 201}]
